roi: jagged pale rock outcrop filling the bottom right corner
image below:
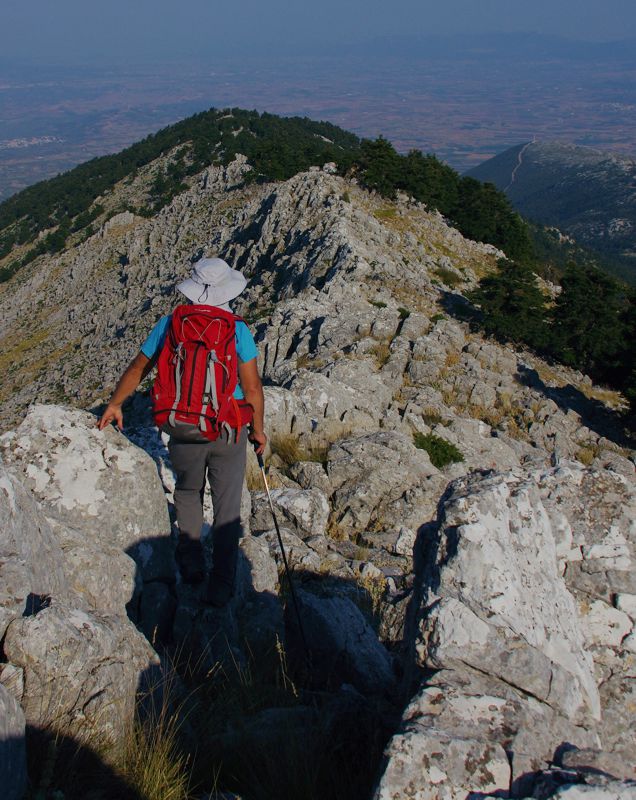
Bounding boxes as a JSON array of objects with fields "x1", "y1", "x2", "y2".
[{"x1": 375, "y1": 463, "x2": 636, "y2": 800}]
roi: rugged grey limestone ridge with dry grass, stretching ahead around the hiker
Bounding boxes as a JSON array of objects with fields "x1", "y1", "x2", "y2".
[{"x1": 0, "y1": 152, "x2": 636, "y2": 800}]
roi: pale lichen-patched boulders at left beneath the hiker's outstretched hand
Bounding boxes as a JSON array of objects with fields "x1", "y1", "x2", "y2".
[{"x1": 0, "y1": 416, "x2": 166, "y2": 740}]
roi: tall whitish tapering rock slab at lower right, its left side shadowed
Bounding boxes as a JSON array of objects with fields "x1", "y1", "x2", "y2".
[{"x1": 418, "y1": 473, "x2": 600, "y2": 718}]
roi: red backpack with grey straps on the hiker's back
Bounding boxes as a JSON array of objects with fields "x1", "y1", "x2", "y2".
[{"x1": 152, "y1": 305, "x2": 253, "y2": 441}]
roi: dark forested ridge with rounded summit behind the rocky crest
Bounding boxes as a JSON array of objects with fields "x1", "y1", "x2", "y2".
[{"x1": 0, "y1": 109, "x2": 532, "y2": 281}]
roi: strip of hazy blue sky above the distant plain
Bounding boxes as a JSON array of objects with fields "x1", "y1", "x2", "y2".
[{"x1": 0, "y1": 0, "x2": 636, "y2": 61}]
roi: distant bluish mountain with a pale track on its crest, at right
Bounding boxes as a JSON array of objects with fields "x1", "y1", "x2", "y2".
[{"x1": 467, "y1": 141, "x2": 636, "y2": 282}]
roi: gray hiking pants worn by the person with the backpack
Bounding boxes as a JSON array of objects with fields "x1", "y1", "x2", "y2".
[{"x1": 168, "y1": 428, "x2": 247, "y2": 584}]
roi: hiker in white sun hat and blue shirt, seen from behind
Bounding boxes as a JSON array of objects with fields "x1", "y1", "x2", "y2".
[{"x1": 97, "y1": 258, "x2": 267, "y2": 607}]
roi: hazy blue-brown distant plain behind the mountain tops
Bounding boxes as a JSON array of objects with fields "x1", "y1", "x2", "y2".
[{"x1": 0, "y1": 38, "x2": 636, "y2": 199}]
